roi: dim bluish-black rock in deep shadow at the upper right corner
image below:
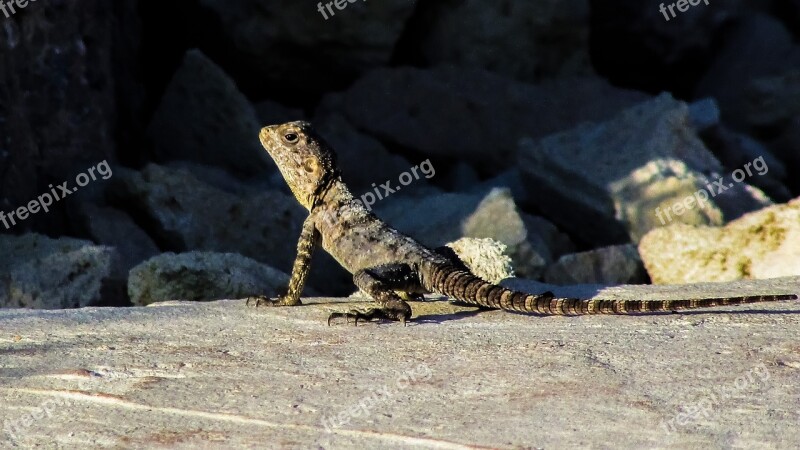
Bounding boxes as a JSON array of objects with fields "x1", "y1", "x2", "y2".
[{"x1": 695, "y1": 13, "x2": 800, "y2": 126}]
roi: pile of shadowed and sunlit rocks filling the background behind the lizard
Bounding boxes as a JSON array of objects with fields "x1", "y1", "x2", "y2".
[{"x1": 0, "y1": 0, "x2": 800, "y2": 308}]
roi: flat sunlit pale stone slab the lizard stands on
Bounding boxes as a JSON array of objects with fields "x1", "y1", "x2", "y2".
[{"x1": 0, "y1": 277, "x2": 800, "y2": 449}]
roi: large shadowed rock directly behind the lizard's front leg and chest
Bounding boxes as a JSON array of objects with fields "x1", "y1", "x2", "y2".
[{"x1": 113, "y1": 164, "x2": 352, "y2": 293}]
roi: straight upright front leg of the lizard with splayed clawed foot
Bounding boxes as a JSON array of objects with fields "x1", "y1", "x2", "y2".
[{"x1": 246, "y1": 215, "x2": 320, "y2": 307}]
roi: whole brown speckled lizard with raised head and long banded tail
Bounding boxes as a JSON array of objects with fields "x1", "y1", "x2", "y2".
[{"x1": 246, "y1": 121, "x2": 797, "y2": 325}]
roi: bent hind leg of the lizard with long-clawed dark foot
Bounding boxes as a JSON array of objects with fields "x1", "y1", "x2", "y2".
[{"x1": 328, "y1": 264, "x2": 421, "y2": 325}]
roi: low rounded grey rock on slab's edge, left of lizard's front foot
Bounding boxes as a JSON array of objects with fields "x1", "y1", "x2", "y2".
[{"x1": 128, "y1": 252, "x2": 300, "y2": 306}]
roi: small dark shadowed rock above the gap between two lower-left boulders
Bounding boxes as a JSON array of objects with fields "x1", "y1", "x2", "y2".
[{"x1": 77, "y1": 203, "x2": 161, "y2": 273}]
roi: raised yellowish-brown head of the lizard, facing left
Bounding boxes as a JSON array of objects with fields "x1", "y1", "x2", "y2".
[{"x1": 259, "y1": 121, "x2": 339, "y2": 210}]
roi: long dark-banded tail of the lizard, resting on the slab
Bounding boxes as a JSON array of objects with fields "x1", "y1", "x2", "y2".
[{"x1": 426, "y1": 266, "x2": 797, "y2": 316}]
